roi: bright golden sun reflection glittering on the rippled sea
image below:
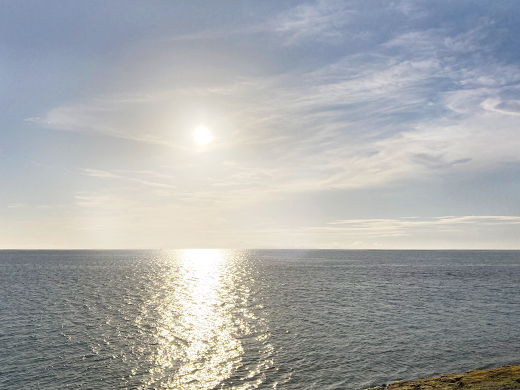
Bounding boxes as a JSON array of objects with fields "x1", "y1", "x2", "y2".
[{"x1": 143, "y1": 249, "x2": 272, "y2": 390}]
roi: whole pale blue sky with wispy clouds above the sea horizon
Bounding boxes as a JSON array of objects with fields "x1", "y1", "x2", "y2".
[{"x1": 0, "y1": 0, "x2": 520, "y2": 249}]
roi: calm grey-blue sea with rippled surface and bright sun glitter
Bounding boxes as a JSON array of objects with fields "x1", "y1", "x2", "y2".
[{"x1": 0, "y1": 250, "x2": 520, "y2": 390}]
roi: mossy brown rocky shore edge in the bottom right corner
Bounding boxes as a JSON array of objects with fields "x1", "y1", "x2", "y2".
[{"x1": 370, "y1": 366, "x2": 520, "y2": 390}]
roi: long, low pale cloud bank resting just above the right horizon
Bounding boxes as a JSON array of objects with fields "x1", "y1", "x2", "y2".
[{"x1": 229, "y1": 216, "x2": 520, "y2": 249}]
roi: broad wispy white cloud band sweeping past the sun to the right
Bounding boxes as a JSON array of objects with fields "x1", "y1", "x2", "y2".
[{"x1": 35, "y1": 29, "x2": 520, "y2": 204}]
